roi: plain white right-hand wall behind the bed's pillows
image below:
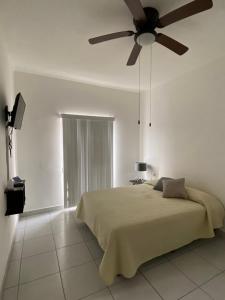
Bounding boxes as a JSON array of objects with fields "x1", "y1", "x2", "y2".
[{"x1": 144, "y1": 58, "x2": 225, "y2": 203}]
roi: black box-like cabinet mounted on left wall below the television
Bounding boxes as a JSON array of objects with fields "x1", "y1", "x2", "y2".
[{"x1": 5, "y1": 180, "x2": 25, "y2": 216}]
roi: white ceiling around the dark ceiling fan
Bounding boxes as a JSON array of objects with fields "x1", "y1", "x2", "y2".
[{"x1": 0, "y1": 0, "x2": 225, "y2": 88}]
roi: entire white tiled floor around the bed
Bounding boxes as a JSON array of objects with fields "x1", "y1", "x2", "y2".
[{"x1": 3, "y1": 210, "x2": 225, "y2": 300}]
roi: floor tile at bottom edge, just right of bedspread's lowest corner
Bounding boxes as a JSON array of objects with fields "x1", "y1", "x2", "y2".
[{"x1": 110, "y1": 275, "x2": 161, "y2": 300}]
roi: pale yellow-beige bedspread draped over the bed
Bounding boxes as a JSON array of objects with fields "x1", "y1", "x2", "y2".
[{"x1": 77, "y1": 184, "x2": 224, "y2": 285}]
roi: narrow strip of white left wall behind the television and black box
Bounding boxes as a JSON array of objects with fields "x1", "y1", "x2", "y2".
[{"x1": 0, "y1": 41, "x2": 18, "y2": 293}]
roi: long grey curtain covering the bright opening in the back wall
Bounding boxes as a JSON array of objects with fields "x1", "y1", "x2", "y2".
[{"x1": 62, "y1": 115, "x2": 114, "y2": 207}]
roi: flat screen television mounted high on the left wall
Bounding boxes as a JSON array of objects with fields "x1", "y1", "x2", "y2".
[{"x1": 8, "y1": 93, "x2": 26, "y2": 129}]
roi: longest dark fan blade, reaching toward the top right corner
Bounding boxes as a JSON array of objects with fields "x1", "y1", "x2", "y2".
[{"x1": 157, "y1": 0, "x2": 213, "y2": 28}]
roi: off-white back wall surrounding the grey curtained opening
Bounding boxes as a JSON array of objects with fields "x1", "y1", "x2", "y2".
[{"x1": 15, "y1": 72, "x2": 139, "y2": 211}]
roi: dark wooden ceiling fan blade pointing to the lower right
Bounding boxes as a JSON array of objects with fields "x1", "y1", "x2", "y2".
[{"x1": 155, "y1": 33, "x2": 188, "y2": 55}]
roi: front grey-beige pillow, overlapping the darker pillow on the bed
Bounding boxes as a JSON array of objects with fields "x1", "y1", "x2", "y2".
[{"x1": 163, "y1": 178, "x2": 187, "y2": 199}]
